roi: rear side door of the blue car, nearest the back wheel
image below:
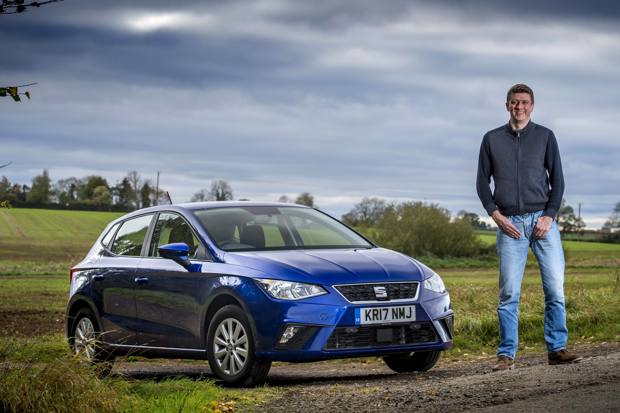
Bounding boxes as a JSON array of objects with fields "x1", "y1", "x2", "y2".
[{"x1": 91, "y1": 214, "x2": 153, "y2": 345}]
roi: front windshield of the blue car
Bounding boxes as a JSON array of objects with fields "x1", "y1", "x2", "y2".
[{"x1": 194, "y1": 206, "x2": 373, "y2": 251}]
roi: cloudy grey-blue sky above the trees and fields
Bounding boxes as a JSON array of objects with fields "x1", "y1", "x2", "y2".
[{"x1": 0, "y1": 0, "x2": 620, "y2": 228}]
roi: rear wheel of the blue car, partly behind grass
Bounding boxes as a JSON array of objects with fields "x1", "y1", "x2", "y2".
[{"x1": 69, "y1": 308, "x2": 114, "y2": 377}]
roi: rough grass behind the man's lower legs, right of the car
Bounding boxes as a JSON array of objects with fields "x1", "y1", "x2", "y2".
[{"x1": 441, "y1": 268, "x2": 620, "y2": 353}]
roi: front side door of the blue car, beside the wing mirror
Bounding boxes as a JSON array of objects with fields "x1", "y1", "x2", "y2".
[{"x1": 135, "y1": 212, "x2": 208, "y2": 349}]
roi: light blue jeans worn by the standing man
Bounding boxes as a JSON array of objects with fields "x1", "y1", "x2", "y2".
[{"x1": 497, "y1": 211, "x2": 568, "y2": 358}]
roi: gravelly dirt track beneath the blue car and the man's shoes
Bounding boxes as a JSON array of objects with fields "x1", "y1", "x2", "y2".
[{"x1": 115, "y1": 343, "x2": 620, "y2": 413}]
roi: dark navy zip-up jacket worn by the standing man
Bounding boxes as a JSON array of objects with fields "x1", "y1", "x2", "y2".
[{"x1": 476, "y1": 121, "x2": 564, "y2": 218}]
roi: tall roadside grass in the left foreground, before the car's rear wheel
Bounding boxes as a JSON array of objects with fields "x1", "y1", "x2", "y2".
[{"x1": 0, "y1": 335, "x2": 278, "y2": 413}]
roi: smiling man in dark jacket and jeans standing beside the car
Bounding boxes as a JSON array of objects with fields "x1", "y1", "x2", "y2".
[{"x1": 476, "y1": 84, "x2": 581, "y2": 371}]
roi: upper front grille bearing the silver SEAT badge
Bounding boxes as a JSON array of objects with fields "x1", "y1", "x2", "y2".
[{"x1": 334, "y1": 282, "x2": 419, "y2": 303}]
